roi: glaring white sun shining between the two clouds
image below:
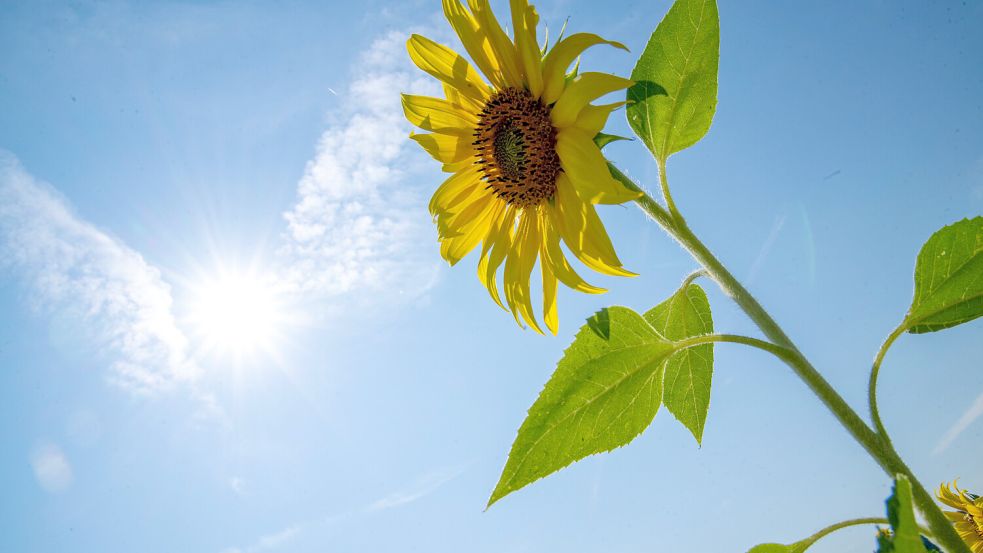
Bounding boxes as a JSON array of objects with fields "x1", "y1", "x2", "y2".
[{"x1": 189, "y1": 271, "x2": 285, "y2": 360}]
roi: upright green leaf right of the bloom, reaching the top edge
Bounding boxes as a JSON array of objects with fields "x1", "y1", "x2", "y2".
[{"x1": 626, "y1": 0, "x2": 720, "y2": 161}]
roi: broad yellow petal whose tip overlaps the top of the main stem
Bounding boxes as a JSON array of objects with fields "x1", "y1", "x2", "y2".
[{"x1": 556, "y1": 127, "x2": 641, "y2": 204}]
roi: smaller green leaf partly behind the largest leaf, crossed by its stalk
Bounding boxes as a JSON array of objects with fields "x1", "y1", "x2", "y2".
[{"x1": 645, "y1": 284, "x2": 713, "y2": 443}]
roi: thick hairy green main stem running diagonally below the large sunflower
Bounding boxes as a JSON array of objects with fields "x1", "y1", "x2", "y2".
[{"x1": 609, "y1": 167, "x2": 971, "y2": 553}]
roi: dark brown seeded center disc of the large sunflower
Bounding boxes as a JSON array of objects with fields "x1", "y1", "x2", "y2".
[{"x1": 474, "y1": 88, "x2": 561, "y2": 207}]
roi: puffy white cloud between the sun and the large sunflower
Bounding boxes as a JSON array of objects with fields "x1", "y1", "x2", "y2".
[{"x1": 281, "y1": 32, "x2": 439, "y2": 306}]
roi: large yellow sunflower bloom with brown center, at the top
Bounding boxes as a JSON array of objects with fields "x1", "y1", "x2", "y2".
[{"x1": 403, "y1": 0, "x2": 640, "y2": 334}]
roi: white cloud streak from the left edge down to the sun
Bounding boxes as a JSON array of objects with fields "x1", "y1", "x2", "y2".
[{"x1": 0, "y1": 151, "x2": 197, "y2": 393}]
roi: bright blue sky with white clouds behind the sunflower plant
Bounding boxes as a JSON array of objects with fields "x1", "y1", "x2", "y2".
[{"x1": 0, "y1": 0, "x2": 983, "y2": 553}]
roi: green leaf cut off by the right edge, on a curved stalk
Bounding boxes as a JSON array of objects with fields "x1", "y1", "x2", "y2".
[{"x1": 905, "y1": 217, "x2": 983, "y2": 334}]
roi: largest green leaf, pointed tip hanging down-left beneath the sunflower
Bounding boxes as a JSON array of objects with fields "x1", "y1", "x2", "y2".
[{"x1": 488, "y1": 307, "x2": 674, "y2": 506}]
